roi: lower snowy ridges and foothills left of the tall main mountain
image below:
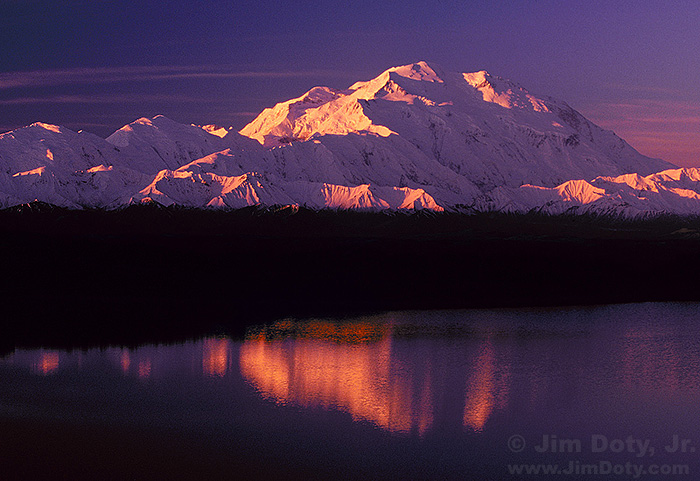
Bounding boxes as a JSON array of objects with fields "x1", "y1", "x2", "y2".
[{"x1": 0, "y1": 116, "x2": 443, "y2": 210}]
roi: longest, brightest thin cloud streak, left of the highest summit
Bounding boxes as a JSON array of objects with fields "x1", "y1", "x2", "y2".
[{"x1": 0, "y1": 65, "x2": 347, "y2": 90}]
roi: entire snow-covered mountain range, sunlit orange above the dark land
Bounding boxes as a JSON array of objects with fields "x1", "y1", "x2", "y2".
[{"x1": 0, "y1": 62, "x2": 700, "y2": 215}]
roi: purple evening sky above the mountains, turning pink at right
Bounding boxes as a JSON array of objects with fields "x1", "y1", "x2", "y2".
[{"x1": 0, "y1": 0, "x2": 700, "y2": 166}]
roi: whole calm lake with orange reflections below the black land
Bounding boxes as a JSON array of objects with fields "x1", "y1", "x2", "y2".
[{"x1": 0, "y1": 304, "x2": 700, "y2": 479}]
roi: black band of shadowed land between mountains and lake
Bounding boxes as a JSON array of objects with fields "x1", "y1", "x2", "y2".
[{"x1": 0, "y1": 204, "x2": 700, "y2": 352}]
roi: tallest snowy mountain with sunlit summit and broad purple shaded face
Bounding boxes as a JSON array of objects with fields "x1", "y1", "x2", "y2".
[{"x1": 241, "y1": 62, "x2": 674, "y2": 199}]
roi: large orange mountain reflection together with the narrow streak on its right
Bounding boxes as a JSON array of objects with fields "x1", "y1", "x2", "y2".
[{"x1": 240, "y1": 319, "x2": 509, "y2": 435}]
